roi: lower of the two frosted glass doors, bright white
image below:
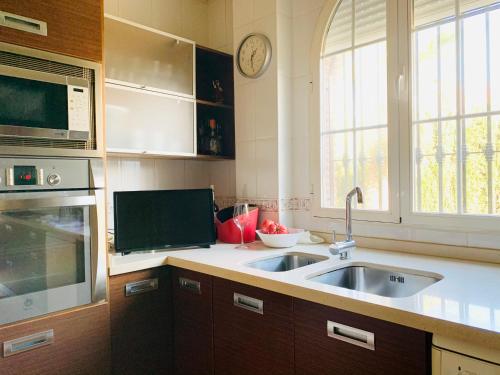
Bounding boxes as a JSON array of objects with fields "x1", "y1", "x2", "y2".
[{"x1": 106, "y1": 83, "x2": 196, "y2": 155}]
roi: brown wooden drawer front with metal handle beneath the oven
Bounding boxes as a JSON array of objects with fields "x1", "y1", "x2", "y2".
[{"x1": 0, "y1": 303, "x2": 110, "y2": 375}]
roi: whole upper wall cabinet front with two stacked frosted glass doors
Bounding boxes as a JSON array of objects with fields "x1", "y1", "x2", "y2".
[{"x1": 104, "y1": 16, "x2": 196, "y2": 156}]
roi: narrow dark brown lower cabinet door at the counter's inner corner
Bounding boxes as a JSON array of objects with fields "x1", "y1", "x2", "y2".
[{"x1": 172, "y1": 268, "x2": 214, "y2": 375}]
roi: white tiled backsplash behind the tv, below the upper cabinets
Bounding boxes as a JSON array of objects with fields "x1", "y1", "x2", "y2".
[{"x1": 107, "y1": 157, "x2": 236, "y2": 228}]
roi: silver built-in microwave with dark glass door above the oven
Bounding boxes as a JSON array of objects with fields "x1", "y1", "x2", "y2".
[{"x1": 0, "y1": 66, "x2": 91, "y2": 140}]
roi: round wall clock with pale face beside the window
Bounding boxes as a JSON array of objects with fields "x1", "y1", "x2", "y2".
[{"x1": 236, "y1": 33, "x2": 272, "y2": 78}]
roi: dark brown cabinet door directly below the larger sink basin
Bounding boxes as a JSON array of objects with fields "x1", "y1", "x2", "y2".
[{"x1": 294, "y1": 300, "x2": 431, "y2": 375}]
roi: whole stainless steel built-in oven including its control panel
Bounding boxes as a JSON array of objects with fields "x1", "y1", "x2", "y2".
[{"x1": 0, "y1": 158, "x2": 106, "y2": 324}]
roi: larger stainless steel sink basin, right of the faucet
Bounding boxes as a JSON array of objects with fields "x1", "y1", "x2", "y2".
[{"x1": 309, "y1": 264, "x2": 443, "y2": 298}]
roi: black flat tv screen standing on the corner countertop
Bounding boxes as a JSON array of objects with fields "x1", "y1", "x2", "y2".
[{"x1": 113, "y1": 189, "x2": 215, "y2": 253}]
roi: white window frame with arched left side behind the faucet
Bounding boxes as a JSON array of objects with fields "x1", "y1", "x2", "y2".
[{"x1": 309, "y1": 0, "x2": 500, "y2": 232}]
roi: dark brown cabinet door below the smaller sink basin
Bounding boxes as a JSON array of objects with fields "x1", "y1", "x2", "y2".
[{"x1": 213, "y1": 278, "x2": 294, "y2": 375}]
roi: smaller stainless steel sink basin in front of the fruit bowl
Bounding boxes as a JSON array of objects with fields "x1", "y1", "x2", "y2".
[{"x1": 246, "y1": 252, "x2": 328, "y2": 272}]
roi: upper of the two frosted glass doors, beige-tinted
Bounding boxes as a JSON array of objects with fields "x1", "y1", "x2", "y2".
[{"x1": 104, "y1": 17, "x2": 194, "y2": 97}]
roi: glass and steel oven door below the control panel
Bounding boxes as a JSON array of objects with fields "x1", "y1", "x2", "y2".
[{"x1": 0, "y1": 193, "x2": 95, "y2": 324}]
